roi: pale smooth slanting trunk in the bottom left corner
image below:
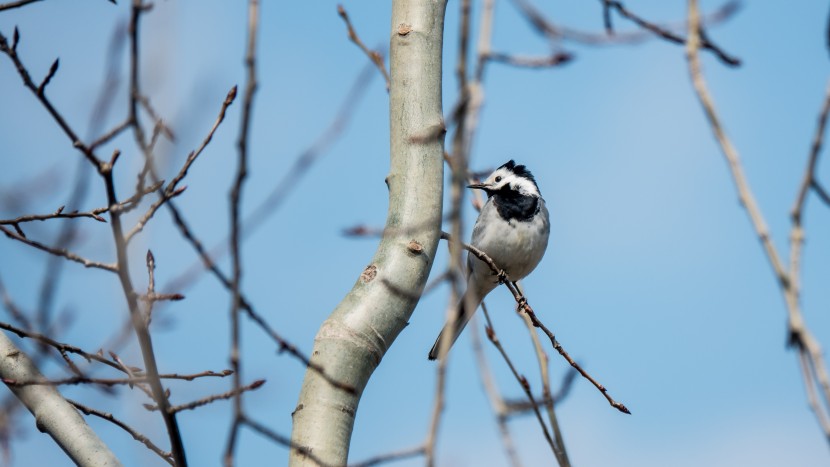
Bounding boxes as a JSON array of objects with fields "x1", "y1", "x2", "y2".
[{"x1": 0, "y1": 332, "x2": 121, "y2": 467}]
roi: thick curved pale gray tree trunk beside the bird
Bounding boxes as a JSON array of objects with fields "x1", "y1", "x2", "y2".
[{"x1": 290, "y1": 0, "x2": 446, "y2": 466}]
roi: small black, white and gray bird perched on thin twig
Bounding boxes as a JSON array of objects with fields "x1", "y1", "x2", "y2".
[{"x1": 429, "y1": 159, "x2": 550, "y2": 360}]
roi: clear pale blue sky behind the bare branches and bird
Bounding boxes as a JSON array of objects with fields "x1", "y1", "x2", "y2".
[{"x1": 0, "y1": 0, "x2": 830, "y2": 466}]
